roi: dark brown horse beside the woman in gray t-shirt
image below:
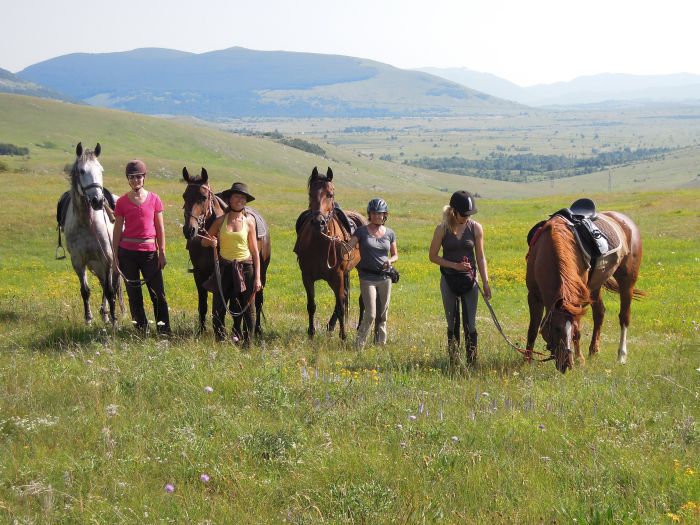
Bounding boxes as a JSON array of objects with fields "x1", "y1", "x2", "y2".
[{"x1": 294, "y1": 167, "x2": 366, "y2": 339}]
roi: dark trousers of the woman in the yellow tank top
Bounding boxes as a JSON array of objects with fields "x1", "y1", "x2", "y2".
[{"x1": 212, "y1": 261, "x2": 255, "y2": 345}]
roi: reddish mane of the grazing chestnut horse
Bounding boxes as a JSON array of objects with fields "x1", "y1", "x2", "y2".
[{"x1": 546, "y1": 220, "x2": 591, "y2": 316}]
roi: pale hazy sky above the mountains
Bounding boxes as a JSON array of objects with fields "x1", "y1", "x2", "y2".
[{"x1": 5, "y1": 0, "x2": 700, "y2": 85}]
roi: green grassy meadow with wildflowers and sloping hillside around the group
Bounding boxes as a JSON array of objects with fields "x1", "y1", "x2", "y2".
[{"x1": 0, "y1": 96, "x2": 700, "y2": 523}]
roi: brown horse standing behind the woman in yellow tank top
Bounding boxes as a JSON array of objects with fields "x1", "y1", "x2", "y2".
[{"x1": 182, "y1": 168, "x2": 272, "y2": 336}]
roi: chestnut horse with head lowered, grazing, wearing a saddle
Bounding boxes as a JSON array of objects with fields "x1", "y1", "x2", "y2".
[{"x1": 526, "y1": 211, "x2": 644, "y2": 373}]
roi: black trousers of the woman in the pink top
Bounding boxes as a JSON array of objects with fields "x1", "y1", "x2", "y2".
[{"x1": 119, "y1": 247, "x2": 170, "y2": 334}]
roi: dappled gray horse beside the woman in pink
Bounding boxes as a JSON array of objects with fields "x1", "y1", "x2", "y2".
[{"x1": 65, "y1": 143, "x2": 119, "y2": 324}]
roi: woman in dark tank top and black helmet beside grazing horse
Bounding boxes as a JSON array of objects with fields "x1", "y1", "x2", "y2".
[{"x1": 429, "y1": 191, "x2": 491, "y2": 370}]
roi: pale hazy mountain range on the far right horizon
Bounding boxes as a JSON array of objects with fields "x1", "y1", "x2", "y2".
[{"x1": 417, "y1": 67, "x2": 700, "y2": 107}]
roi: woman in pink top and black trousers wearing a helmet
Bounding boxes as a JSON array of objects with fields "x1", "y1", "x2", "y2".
[{"x1": 114, "y1": 160, "x2": 170, "y2": 335}]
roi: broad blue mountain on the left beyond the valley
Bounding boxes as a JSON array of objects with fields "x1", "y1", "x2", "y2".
[{"x1": 17, "y1": 47, "x2": 523, "y2": 120}]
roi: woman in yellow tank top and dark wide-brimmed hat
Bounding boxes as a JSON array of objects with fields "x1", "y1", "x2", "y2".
[{"x1": 202, "y1": 182, "x2": 262, "y2": 346}]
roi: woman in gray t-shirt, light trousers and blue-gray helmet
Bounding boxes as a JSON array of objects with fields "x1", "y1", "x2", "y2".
[{"x1": 350, "y1": 199, "x2": 399, "y2": 349}]
